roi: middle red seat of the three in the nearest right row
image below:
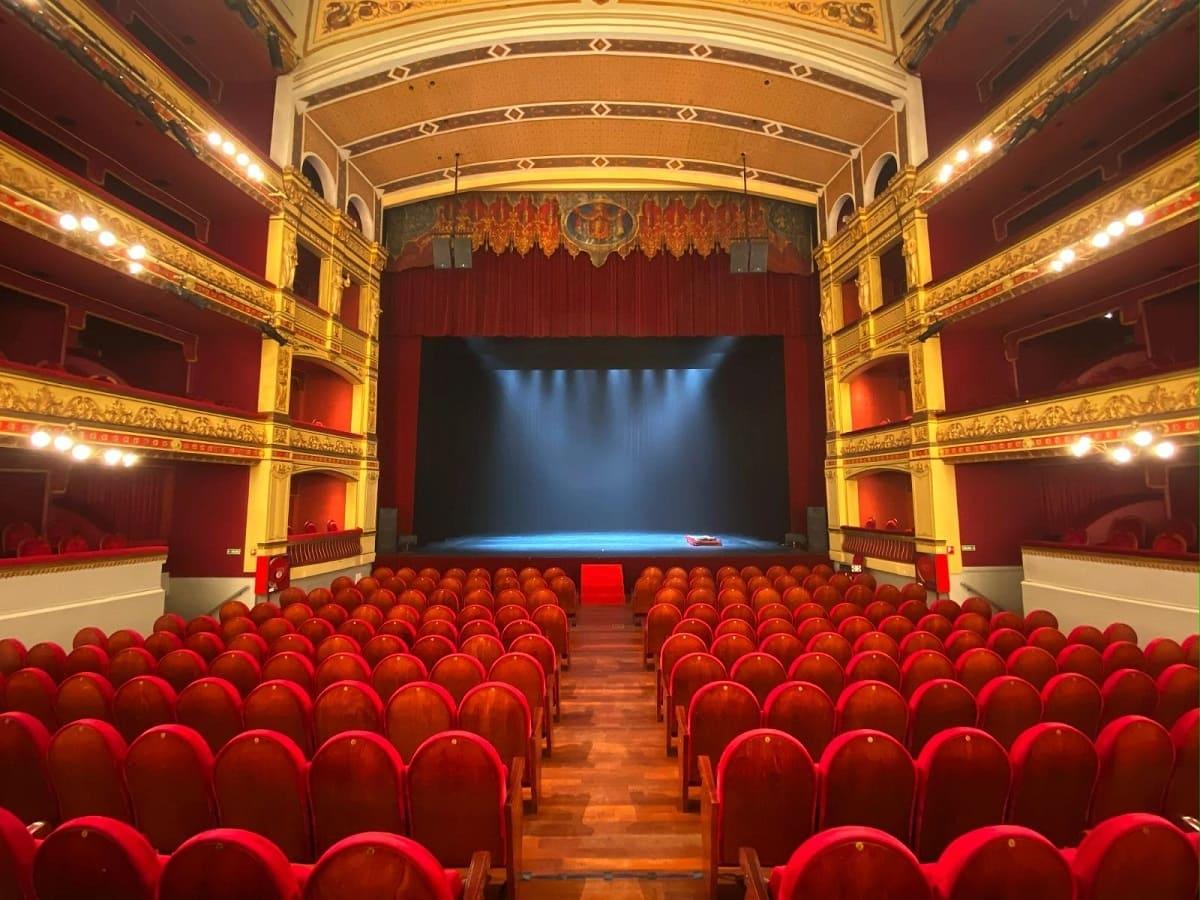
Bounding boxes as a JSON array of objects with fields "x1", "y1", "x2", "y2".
[{"x1": 930, "y1": 824, "x2": 1075, "y2": 900}]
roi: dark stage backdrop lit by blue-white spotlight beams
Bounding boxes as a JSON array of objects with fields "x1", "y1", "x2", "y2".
[{"x1": 414, "y1": 337, "x2": 788, "y2": 541}]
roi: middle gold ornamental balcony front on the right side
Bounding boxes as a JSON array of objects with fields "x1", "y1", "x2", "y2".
[{"x1": 912, "y1": 143, "x2": 1200, "y2": 328}]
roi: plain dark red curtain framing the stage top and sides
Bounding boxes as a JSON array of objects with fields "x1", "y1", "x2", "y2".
[{"x1": 378, "y1": 252, "x2": 824, "y2": 534}]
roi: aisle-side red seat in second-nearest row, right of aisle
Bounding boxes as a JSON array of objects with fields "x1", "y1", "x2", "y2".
[{"x1": 709, "y1": 728, "x2": 817, "y2": 865}]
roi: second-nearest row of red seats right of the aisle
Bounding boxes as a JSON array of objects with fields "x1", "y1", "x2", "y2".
[{"x1": 692, "y1": 710, "x2": 1200, "y2": 878}]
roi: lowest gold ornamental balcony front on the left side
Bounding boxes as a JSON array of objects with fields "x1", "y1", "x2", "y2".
[{"x1": 0, "y1": 372, "x2": 266, "y2": 445}]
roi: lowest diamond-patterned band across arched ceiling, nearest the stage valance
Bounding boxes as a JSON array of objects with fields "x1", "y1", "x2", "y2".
[{"x1": 379, "y1": 156, "x2": 821, "y2": 193}]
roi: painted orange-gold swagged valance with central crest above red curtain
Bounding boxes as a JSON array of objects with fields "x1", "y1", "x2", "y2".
[{"x1": 384, "y1": 192, "x2": 815, "y2": 275}]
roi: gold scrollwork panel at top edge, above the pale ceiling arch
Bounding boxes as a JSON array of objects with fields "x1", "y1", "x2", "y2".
[{"x1": 307, "y1": 0, "x2": 893, "y2": 52}]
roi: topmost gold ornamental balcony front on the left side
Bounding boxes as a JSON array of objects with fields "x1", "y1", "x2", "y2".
[{"x1": 5, "y1": 0, "x2": 283, "y2": 209}]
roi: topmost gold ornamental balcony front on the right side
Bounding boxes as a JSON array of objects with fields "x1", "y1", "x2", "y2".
[{"x1": 914, "y1": 0, "x2": 1195, "y2": 206}]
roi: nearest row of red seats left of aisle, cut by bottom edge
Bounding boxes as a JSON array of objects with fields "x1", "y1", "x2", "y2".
[{"x1": 0, "y1": 810, "x2": 491, "y2": 900}]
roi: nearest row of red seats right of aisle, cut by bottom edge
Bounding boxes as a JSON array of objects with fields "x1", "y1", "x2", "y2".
[{"x1": 742, "y1": 812, "x2": 1198, "y2": 900}]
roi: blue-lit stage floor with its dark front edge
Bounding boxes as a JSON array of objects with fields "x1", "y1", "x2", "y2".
[{"x1": 378, "y1": 532, "x2": 826, "y2": 592}]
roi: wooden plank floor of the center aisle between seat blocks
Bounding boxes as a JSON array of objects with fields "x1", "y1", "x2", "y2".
[{"x1": 521, "y1": 606, "x2": 703, "y2": 900}]
